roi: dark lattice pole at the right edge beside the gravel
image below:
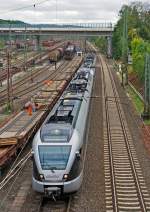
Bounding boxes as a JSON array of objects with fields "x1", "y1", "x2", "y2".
[{"x1": 143, "y1": 54, "x2": 150, "y2": 118}]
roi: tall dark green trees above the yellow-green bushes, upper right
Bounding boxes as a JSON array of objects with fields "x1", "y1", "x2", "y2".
[{"x1": 113, "y1": 2, "x2": 150, "y2": 59}]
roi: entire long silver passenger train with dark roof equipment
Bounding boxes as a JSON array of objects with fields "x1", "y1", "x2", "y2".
[{"x1": 32, "y1": 56, "x2": 95, "y2": 196}]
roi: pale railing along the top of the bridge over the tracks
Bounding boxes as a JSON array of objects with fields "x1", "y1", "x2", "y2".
[{"x1": 0, "y1": 22, "x2": 114, "y2": 29}]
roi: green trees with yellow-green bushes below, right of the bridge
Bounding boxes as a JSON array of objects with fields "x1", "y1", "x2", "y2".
[{"x1": 113, "y1": 2, "x2": 150, "y2": 80}]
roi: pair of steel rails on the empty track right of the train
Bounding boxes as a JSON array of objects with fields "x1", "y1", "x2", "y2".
[{"x1": 101, "y1": 55, "x2": 147, "y2": 212}]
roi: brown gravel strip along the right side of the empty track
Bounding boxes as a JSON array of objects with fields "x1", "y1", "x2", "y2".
[{"x1": 110, "y1": 58, "x2": 150, "y2": 193}]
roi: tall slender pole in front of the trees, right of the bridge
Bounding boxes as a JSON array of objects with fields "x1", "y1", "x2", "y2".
[{"x1": 122, "y1": 6, "x2": 128, "y2": 86}]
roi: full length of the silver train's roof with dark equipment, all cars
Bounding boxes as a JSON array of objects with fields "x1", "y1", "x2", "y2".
[{"x1": 40, "y1": 60, "x2": 95, "y2": 144}]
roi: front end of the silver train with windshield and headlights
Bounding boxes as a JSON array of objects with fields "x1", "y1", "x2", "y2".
[{"x1": 32, "y1": 124, "x2": 83, "y2": 196}]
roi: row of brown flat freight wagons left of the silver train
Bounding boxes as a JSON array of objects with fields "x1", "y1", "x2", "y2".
[{"x1": 0, "y1": 57, "x2": 82, "y2": 167}]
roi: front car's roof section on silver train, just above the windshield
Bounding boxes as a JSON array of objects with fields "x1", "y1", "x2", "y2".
[{"x1": 40, "y1": 95, "x2": 82, "y2": 143}]
